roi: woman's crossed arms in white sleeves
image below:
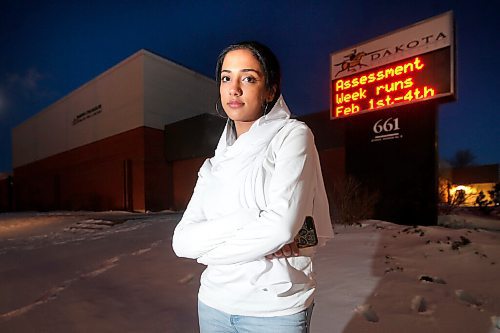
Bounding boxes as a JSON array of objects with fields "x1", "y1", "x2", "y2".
[{"x1": 172, "y1": 126, "x2": 317, "y2": 265}]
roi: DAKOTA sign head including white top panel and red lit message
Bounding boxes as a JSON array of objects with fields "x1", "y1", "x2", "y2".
[{"x1": 330, "y1": 13, "x2": 454, "y2": 119}]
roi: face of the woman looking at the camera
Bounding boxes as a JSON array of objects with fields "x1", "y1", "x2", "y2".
[{"x1": 220, "y1": 49, "x2": 273, "y2": 122}]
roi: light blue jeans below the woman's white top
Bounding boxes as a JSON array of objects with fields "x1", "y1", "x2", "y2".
[{"x1": 198, "y1": 301, "x2": 314, "y2": 333}]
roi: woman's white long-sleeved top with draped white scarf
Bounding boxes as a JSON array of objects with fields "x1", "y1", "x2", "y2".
[{"x1": 172, "y1": 97, "x2": 333, "y2": 317}]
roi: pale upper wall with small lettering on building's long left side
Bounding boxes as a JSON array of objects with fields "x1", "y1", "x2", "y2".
[{"x1": 12, "y1": 52, "x2": 144, "y2": 167}]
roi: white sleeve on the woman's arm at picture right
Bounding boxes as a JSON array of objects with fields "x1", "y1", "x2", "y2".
[{"x1": 198, "y1": 125, "x2": 318, "y2": 265}]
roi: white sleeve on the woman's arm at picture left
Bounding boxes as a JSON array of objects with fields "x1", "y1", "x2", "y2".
[{"x1": 172, "y1": 160, "x2": 259, "y2": 259}]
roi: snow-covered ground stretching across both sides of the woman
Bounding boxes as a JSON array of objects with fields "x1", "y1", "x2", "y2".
[{"x1": 0, "y1": 212, "x2": 500, "y2": 333}]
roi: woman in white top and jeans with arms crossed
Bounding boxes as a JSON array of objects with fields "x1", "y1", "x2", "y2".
[{"x1": 172, "y1": 42, "x2": 333, "y2": 333}]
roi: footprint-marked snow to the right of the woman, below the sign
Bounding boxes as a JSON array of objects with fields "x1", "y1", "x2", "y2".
[{"x1": 313, "y1": 221, "x2": 500, "y2": 333}]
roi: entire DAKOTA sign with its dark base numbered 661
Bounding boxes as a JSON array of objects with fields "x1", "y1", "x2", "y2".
[{"x1": 330, "y1": 12, "x2": 455, "y2": 225}]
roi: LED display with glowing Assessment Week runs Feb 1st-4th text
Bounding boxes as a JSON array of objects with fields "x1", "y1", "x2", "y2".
[{"x1": 331, "y1": 47, "x2": 453, "y2": 119}]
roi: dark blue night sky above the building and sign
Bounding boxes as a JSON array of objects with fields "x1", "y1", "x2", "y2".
[{"x1": 0, "y1": 0, "x2": 500, "y2": 172}]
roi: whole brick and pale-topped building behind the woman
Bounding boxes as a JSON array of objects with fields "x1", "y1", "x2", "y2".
[{"x1": 5, "y1": 50, "x2": 345, "y2": 211}]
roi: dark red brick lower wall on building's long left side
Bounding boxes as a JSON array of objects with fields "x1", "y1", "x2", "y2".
[{"x1": 14, "y1": 127, "x2": 155, "y2": 211}]
